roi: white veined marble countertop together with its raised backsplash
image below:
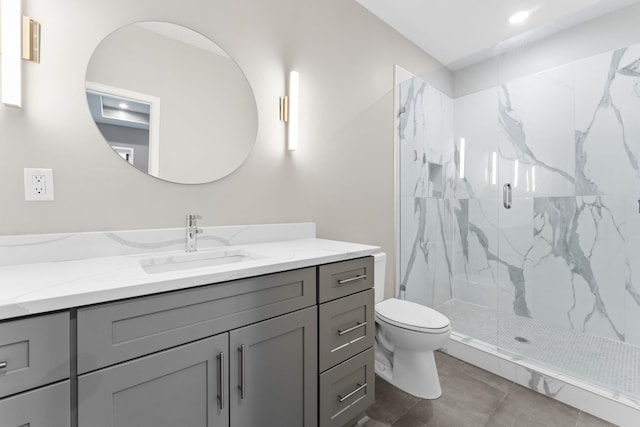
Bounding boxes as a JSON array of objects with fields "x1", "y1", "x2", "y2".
[{"x1": 0, "y1": 224, "x2": 380, "y2": 320}]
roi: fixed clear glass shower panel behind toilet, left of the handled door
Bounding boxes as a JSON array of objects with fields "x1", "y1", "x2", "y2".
[{"x1": 396, "y1": 64, "x2": 500, "y2": 347}]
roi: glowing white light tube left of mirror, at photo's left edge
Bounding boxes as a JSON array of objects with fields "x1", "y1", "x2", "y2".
[{"x1": 0, "y1": 0, "x2": 22, "y2": 107}]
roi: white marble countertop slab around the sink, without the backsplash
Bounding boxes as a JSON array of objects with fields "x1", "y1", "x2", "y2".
[{"x1": 0, "y1": 238, "x2": 380, "y2": 319}]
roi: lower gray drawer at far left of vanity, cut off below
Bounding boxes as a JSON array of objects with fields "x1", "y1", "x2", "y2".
[{"x1": 0, "y1": 381, "x2": 71, "y2": 427}]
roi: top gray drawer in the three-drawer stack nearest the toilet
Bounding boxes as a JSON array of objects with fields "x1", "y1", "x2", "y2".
[{"x1": 318, "y1": 256, "x2": 373, "y2": 303}]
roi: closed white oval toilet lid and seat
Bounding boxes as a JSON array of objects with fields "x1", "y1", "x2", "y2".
[{"x1": 376, "y1": 298, "x2": 451, "y2": 332}]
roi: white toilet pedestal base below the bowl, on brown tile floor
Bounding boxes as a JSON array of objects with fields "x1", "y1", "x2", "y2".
[{"x1": 391, "y1": 347, "x2": 442, "y2": 399}]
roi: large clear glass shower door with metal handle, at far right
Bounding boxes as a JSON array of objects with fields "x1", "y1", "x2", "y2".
[{"x1": 498, "y1": 1, "x2": 640, "y2": 397}]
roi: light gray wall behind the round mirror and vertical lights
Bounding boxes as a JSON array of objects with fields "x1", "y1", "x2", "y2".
[{"x1": 0, "y1": 0, "x2": 440, "y2": 298}]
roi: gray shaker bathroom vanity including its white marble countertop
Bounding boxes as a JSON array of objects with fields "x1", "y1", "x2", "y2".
[{"x1": 0, "y1": 226, "x2": 377, "y2": 427}]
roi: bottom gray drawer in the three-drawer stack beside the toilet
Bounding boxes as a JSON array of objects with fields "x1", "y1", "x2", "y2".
[{"x1": 320, "y1": 348, "x2": 375, "y2": 427}]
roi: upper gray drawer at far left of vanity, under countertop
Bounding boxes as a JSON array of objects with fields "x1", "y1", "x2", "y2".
[{"x1": 0, "y1": 312, "x2": 70, "y2": 397}]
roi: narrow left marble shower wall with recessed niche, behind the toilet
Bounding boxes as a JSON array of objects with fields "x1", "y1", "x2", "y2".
[{"x1": 397, "y1": 77, "x2": 455, "y2": 306}]
